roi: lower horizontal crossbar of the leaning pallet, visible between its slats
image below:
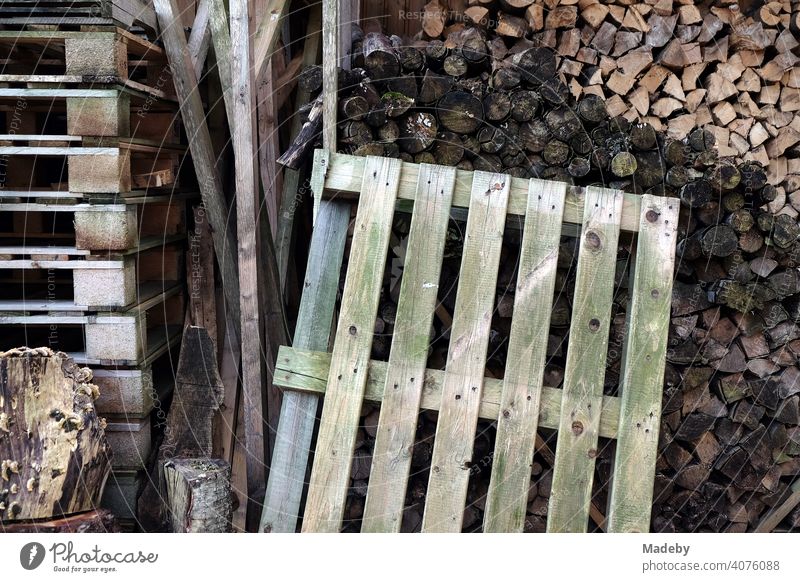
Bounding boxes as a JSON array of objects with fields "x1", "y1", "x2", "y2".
[{"x1": 275, "y1": 346, "x2": 619, "y2": 439}]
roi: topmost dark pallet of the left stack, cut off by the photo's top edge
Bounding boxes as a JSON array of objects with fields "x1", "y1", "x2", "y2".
[{"x1": 0, "y1": 0, "x2": 158, "y2": 35}]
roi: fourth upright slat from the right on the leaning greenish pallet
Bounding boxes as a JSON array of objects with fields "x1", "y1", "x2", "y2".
[{"x1": 422, "y1": 172, "x2": 511, "y2": 532}]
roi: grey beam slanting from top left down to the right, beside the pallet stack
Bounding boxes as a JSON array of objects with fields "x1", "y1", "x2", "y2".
[{"x1": 154, "y1": 0, "x2": 241, "y2": 342}]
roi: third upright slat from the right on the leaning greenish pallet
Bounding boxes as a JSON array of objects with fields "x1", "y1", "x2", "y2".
[{"x1": 483, "y1": 180, "x2": 567, "y2": 532}]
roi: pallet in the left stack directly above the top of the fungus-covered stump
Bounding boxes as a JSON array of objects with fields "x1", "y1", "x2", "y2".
[{"x1": 0, "y1": 285, "x2": 184, "y2": 367}]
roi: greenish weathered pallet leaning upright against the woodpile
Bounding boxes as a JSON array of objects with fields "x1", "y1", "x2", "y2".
[{"x1": 272, "y1": 151, "x2": 679, "y2": 532}]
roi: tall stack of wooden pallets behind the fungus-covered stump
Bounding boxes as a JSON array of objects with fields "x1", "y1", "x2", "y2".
[{"x1": 0, "y1": 26, "x2": 193, "y2": 519}]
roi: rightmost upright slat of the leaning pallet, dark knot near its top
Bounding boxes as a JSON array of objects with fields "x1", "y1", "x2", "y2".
[{"x1": 608, "y1": 195, "x2": 679, "y2": 532}]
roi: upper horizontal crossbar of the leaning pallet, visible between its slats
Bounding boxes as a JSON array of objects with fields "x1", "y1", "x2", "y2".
[{"x1": 314, "y1": 154, "x2": 641, "y2": 232}]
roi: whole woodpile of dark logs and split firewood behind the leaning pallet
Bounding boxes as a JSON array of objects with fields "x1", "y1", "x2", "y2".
[{"x1": 284, "y1": 0, "x2": 800, "y2": 532}]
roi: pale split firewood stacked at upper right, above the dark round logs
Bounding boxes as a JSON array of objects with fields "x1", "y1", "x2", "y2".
[{"x1": 400, "y1": 0, "x2": 800, "y2": 180}]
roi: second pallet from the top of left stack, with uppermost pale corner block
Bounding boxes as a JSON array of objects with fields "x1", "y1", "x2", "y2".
[{"x1": 0, "y1": 28, "x2": 167, "y2": 94}]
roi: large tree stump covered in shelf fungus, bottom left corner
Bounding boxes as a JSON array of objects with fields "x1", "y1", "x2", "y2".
[{"x1": 0, "y1": 348, "x2": 111, "y2": 523}]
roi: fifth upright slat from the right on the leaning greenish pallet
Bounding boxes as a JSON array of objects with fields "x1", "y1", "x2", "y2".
[{"x1": 361, "y1": 164, "x2": 456, "y2": 532}]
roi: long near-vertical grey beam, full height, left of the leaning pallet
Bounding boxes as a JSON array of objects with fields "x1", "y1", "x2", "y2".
[{"x1": 231, "y1": 2, "x2": 266, "y2": 515}]
